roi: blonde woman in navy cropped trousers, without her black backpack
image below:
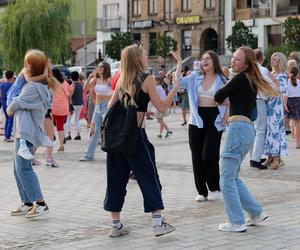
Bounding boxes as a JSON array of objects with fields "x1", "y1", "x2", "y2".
[{"x1": 104, "y1": 45, "x2": 181, "y2": 237}]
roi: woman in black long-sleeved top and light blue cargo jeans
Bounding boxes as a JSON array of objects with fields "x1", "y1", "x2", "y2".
[{"x1": 215, "y1": 46, "x2": 277, "y2": 232}]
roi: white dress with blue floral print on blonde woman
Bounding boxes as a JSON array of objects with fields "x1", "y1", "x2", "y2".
[{"x1": 264, "y1": 73, "x2": 288, "y2": 157}]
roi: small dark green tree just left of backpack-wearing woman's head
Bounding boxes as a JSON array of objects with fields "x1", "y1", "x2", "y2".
[{"x1": 106, "y1": 32, "x2": 132, "y2": 60}]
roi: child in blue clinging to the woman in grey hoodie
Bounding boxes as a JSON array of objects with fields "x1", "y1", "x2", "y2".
[{"x1": 6, "y1": 68, "x2": 53, "y2": 160}]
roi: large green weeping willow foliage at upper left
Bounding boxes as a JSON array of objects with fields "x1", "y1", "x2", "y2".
[{"x1": 1, "y1": 0, "x2": 71, "y2": 71}]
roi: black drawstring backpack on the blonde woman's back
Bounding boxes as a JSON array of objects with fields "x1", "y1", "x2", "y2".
[{"x1": 100, "y1": 74, "x2": 145, "y2": 156}]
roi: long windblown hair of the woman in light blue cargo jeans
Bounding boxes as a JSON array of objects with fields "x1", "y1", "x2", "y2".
[{"x1": 237, "y1": 46, "x2": 279, "y2": 96}]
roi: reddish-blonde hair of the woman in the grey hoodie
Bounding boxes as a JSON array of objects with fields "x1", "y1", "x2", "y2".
[{"x1": 24, "y1": 49, "x2": 57, "y2": 90}]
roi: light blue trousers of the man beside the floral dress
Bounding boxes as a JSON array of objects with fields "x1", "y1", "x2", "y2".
[{"x1": 250, "y1": 99, "x2": 267, "y2": 162}]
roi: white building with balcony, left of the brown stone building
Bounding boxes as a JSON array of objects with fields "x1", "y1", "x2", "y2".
[{"x1": 97, "y1": 0, "x2": 128, "y2": 57}]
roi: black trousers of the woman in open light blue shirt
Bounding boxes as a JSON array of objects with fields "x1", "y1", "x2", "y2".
[{"x1": 189, "y1": 107, "x2": 222, "y2": 197}]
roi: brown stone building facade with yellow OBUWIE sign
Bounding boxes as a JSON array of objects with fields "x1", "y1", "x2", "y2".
[{"x1": 128, "y1": 0, "x2": 224, "y2": 57}]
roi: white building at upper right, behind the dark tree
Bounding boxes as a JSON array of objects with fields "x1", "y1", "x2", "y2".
[{"x1": 224, "y1": 0, "x2": 300, "y2": 54}]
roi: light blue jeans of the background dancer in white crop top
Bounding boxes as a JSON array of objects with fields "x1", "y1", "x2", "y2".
[{"x1": 83, "y1": 101, "x2": 108, "y2": 160}]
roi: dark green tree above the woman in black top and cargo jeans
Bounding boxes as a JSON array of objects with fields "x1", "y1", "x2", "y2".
[{"x1": 226, "y1": 21, "x2": 257, "y2": 52}]
